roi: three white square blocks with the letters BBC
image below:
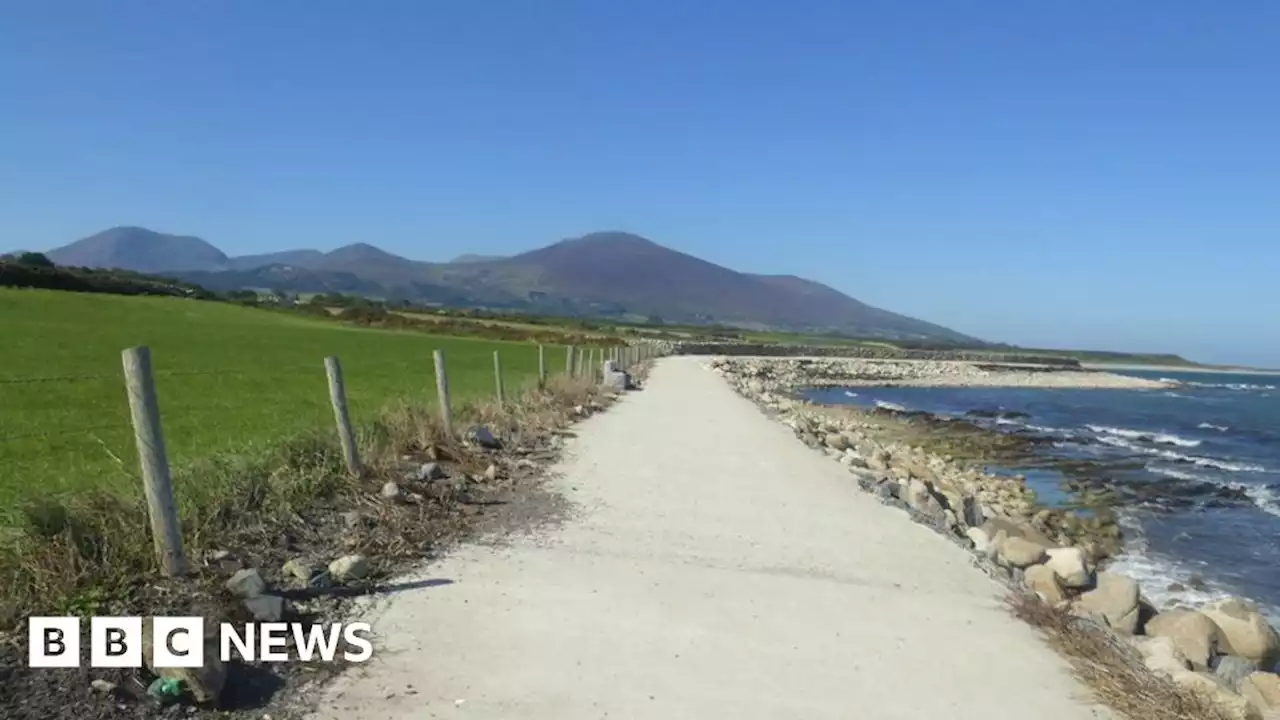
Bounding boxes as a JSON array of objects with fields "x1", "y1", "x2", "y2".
[{"x1": 27, "y1": 618, "x2": 205, "y2": 667}]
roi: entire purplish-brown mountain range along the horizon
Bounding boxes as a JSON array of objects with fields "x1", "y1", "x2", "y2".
[{"x1": 46, "y1": 227, "x2": 979, "y2": 343}]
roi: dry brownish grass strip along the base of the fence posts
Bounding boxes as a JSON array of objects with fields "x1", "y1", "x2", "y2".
[{"x1": 0, "y1": 375, "x2": 619, "y2": 629}]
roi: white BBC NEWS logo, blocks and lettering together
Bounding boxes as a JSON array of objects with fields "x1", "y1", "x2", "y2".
[{"x1": 27, "y1": 618, "x2": 374, "y2": 669}]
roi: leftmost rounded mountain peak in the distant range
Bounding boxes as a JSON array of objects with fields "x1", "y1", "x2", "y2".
[{"x1": 45, "y1": 227, "x2": 227, "y2": 273}]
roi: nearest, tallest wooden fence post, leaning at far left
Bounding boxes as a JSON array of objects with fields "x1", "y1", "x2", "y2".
[{"x1": 120, "y1": 346, "x2": 187, "y2": 578}]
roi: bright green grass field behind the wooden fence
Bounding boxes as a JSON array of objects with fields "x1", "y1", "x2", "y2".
[{"x1": 0, "y1": 288, "x2": 564, "y2": 515}]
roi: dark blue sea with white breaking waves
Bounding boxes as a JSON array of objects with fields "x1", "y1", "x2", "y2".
[{"x1": 806, "y1": 370, "x2": 1280, "y2": 621}]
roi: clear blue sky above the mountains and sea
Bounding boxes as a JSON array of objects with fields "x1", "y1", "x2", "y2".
[{"x1": 0, "y1": 0, "x2": 1280, "y2": 366}]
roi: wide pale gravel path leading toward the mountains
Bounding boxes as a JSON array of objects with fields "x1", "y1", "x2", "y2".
[{"x1": 314, "y1": 357, "x2": 1096, "y2": 720}]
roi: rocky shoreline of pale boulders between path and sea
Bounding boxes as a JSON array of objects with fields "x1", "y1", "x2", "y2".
[{"x1": 710, "y1": 357, "x2": 1280, "y2": 720}]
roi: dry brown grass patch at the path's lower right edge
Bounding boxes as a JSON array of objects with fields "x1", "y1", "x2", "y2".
[{"x1": 1006, "y1": 591, "x2": 1238, "y2": 720}]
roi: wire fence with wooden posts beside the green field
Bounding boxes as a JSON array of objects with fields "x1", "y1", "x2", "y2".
[{"x1": 0, "y1": 345, "x2": 655, "y2": 577}]
